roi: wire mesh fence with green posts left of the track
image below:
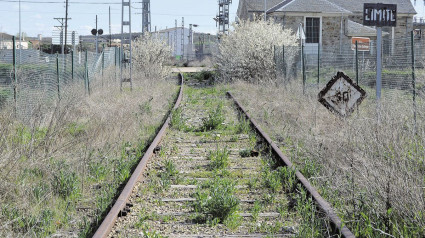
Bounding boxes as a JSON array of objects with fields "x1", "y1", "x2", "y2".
[{"x1": 0, "y1": 48, "x2": 120, "y2": 120}]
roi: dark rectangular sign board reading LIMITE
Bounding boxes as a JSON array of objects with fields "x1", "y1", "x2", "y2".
[{"x1": 363, "y1": 3, "x2": 397, "y2": 27}]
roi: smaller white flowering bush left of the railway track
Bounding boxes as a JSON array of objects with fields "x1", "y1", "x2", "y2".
[{"x1": 133, "y1": 33, "x2": 171, "y2": 78}]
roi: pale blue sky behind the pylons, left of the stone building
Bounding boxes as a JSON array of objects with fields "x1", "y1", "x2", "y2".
[{"x1": 0, "y1": 0, "x2": 239, "y2": 36}]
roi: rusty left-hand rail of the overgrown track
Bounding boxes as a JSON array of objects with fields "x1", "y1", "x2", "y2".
[{"x1": 93, "y1": 74, "x2": 184, "y2": 238}]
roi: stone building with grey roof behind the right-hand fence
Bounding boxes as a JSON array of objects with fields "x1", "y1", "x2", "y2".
[{"x1": 238, "y1": 0, "x2": 416, "y2": 53}]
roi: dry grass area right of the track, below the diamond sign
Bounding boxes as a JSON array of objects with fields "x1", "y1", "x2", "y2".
[{"x1": 233, "y1": 80, "x2": 425, "y2": 237}]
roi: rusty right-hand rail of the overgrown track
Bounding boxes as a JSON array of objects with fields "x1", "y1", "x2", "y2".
[{"x1": 227, "y1": 92, "x2": 355, "y2": 238}]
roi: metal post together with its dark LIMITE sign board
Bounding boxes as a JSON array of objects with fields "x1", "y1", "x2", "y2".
[{"x1": 363, "y1": 3, "x2": 397, "y2": 101}]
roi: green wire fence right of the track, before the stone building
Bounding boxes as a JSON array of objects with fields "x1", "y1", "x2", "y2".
[{"x1": 274, "y1": 34, "x2": 425, "y2": 125}]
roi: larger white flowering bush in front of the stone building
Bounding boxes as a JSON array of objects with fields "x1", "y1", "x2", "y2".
[{"x1": 215, "y1": 20, "x2": 297, "y2": 83}]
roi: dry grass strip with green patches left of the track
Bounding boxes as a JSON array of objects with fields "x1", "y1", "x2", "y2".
[{"x1": 0, "y1": 66, "x2": 177, "y2": 237}]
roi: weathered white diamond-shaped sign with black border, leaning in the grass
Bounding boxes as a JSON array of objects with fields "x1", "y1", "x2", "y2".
[{"x1": 319, "y1": 72, "x2": 366, "y2": 117}]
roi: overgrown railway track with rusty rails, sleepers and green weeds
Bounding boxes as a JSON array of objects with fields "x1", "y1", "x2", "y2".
[{"x1": 94, "y1": 73, "x2": 354, "y2": 237}]
